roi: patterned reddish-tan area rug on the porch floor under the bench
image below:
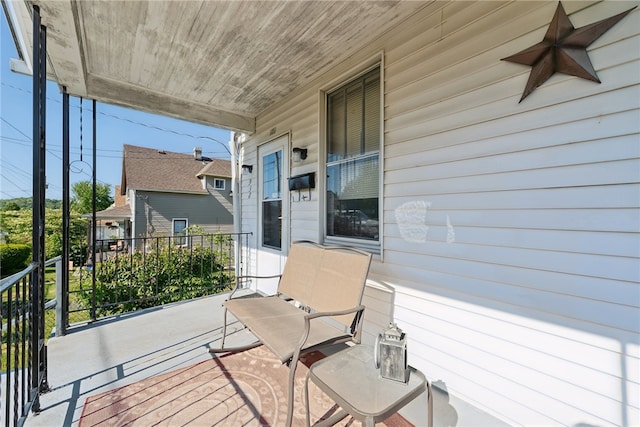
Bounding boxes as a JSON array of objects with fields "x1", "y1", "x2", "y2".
[{"x1": 79, "y1": 347, "x2": 410, "y2": 427}]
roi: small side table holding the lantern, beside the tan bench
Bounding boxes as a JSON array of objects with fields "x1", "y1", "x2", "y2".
[{"x1": 305, "y1": 344, "x2": 433, "y2": 427}]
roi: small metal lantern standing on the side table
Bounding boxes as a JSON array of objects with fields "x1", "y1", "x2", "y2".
[{"x1": 374, "y1": 323, "x2": 409, "y2": 383}]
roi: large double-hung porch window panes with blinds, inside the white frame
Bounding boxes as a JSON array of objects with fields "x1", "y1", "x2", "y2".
[{"x1": 326, "y1": 67, "x2": 381, "y2": 245}]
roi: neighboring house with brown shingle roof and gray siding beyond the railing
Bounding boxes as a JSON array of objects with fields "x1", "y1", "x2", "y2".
[{"x1": 115, "y1": 145, "x2": 233, "y2": 241}]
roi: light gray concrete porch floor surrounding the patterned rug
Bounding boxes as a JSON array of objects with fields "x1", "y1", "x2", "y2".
[{"x1": 26, "y1": 294, "x2": 505, "y2": 427}]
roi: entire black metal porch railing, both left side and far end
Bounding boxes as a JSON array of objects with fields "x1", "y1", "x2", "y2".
[{"x1": 0, "y1": 233, "x2": 251, "y2": 426}]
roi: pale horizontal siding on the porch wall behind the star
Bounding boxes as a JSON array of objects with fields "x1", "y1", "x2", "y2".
[{"x1": 241, "y1": 1, "x2": 640, "y2": 426}]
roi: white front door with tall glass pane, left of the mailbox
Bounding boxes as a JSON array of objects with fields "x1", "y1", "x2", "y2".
[{"x1": 257, "y1": 135, "x2": 289, "y2": 294}]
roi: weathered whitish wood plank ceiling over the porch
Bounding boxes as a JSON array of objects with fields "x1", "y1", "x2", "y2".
[{"x1": 14, "y1": 0, "x2": 428, "y2": 133}]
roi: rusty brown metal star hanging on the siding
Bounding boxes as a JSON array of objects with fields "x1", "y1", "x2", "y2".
[{"x1": 502, "y1": 3, "x2": 635, "y2": 102}]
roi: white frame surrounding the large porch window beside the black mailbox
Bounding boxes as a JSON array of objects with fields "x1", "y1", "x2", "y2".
[{"x1": 318, "y1": 52, "x2": 385, "y2": 261}]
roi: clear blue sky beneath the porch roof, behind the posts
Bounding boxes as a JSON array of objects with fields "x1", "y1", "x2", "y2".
[{"x1": 0, "y1": 13, "x2": 230, "y2": 199}]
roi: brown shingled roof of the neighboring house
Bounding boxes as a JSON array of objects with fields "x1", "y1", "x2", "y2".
[{"x1": 121, "y1": 144, "x2": 231, "y2": 194}]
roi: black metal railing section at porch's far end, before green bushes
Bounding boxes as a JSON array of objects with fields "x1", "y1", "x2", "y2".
[{"x1": 67, "y1": 233, "x2": 250, "y2": 324}]
